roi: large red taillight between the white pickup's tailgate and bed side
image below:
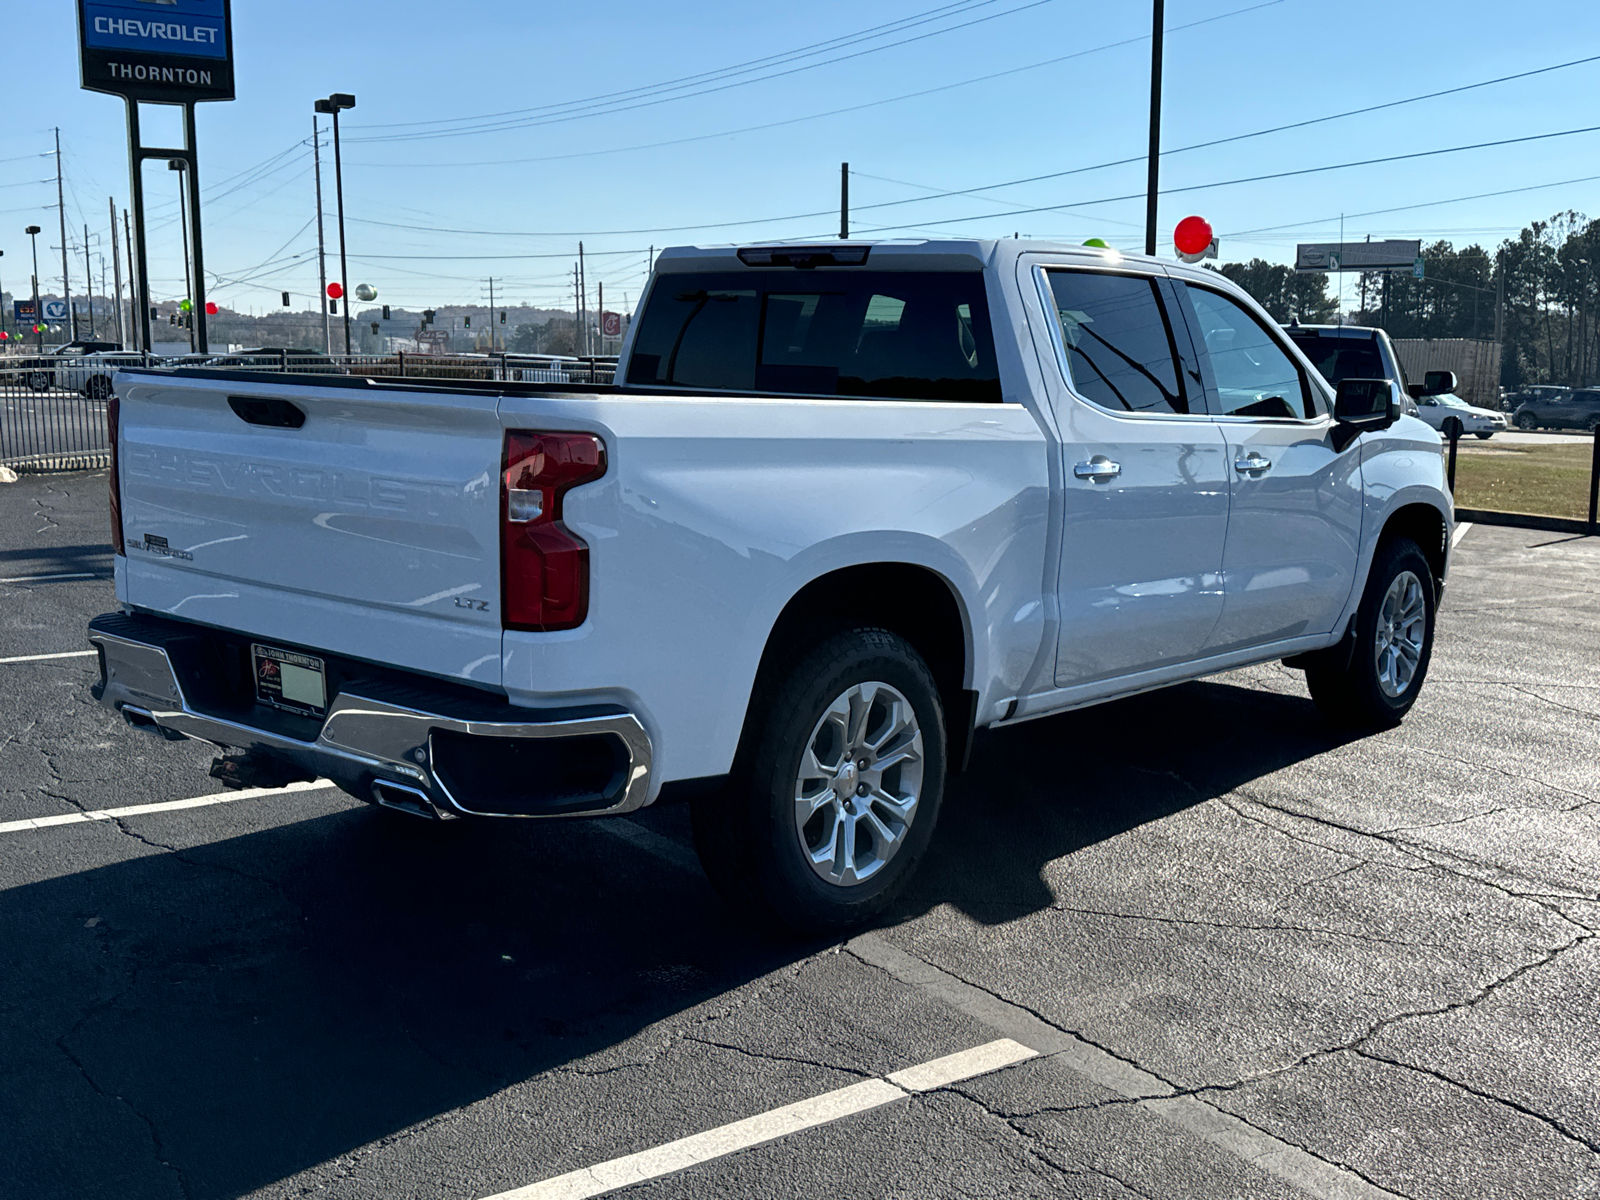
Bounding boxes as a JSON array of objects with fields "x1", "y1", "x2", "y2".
[{"x1": 501, "y1": 429, "x2": 605, "y2": 630}]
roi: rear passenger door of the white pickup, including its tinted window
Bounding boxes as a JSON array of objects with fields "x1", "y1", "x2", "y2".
[{"x1": 1040, "y1": 267, "x2": 1229, "y2": 686}]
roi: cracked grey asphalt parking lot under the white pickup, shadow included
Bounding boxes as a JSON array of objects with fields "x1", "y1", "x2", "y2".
[{"x1": 0, "y1": 474, "x2": 1600, "y2": 1200}]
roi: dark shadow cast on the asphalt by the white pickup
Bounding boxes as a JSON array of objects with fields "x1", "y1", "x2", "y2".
[{"x1": 0, "y1": 683, "x2": 1334, "y2": 1200}]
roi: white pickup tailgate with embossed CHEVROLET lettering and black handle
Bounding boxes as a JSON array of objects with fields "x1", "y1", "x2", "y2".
[{"x1": 117, "y1": 373, "x2": 501, "y2": 686}]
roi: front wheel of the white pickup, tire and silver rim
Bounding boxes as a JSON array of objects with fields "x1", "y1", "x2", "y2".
[{"x1": 1306, "y1": 538, "x2": 1437, "y2": 730}]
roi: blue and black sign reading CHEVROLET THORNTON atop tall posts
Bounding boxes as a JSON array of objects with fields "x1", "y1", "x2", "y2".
[{"x1": 78, "y1": 0, "x2": 234, "y2": 104}]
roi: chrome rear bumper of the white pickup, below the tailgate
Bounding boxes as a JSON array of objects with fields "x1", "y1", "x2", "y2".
[{"x1": 88, "y1": 614, "x2": 651, "y2": 816}]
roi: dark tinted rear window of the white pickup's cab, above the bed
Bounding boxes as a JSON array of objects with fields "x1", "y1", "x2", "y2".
[{"x1": 627, "y1": 269, "x2": 1000, "y2": 402}]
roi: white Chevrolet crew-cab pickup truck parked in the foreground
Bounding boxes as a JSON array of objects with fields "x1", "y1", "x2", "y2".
[{"x1": 90, "y1": 240, "x2": 1453, "y2": 931}]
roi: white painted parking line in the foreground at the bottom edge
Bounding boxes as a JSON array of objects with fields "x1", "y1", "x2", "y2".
[{"x1": 488, "y1": 1038, "x2": 1037, "y2": 1200}]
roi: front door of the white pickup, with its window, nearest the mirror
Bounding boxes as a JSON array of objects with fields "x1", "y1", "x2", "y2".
[{"x1": 1179, "y1": 283, "x2": 1362, "y2": 654}]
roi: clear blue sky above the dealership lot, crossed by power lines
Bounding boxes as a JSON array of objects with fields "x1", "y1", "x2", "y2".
[{"x1": 0, "y1": 0, "x2": 1600, "y2": 312}]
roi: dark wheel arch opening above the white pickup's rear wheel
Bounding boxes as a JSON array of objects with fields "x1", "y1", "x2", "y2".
[{"x1": 739, "y1": 562, "x2": 978, "y2": 771}]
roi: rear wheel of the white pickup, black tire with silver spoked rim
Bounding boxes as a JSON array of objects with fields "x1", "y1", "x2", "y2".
[{"x1": 691, "y1": 629, "x2": 946, "y2": 936}]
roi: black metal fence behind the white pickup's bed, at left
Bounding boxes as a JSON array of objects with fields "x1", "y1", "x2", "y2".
[{"x1": 0, "y1": 352, "x2": 616, "y2": 470}]
